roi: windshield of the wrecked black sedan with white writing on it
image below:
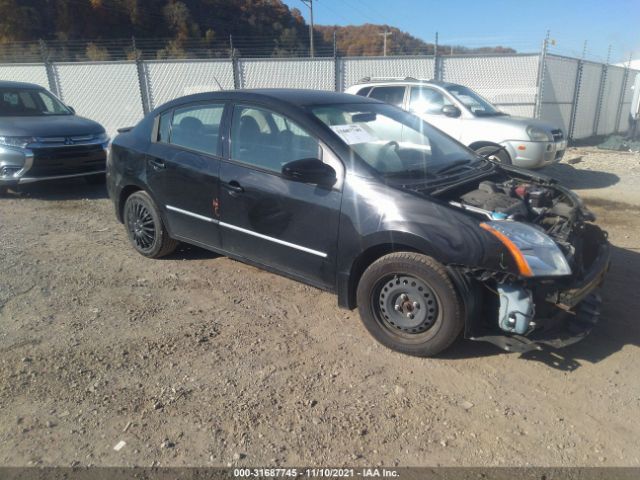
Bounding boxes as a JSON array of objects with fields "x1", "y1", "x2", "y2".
[{"x1": 311, "y1": 103, "x2": 478, "y2": 179}]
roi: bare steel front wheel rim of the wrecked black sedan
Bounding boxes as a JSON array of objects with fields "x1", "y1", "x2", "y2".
[{"x1": 374, "y1": 275, "x2": 439, "y2": 334}]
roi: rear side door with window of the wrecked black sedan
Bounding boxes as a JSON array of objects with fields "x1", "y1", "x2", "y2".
[{"x1": 147, "y1": 102, "x2": 225, "y2": 248}]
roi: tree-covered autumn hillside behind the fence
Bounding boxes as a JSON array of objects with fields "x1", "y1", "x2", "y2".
[{"x1": 0, "y1": 0, "x2": 513, "y2": 60}]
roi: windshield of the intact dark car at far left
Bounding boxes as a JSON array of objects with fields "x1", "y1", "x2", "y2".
[{"x1": 0, "y1": 88, "x2": 71, "y2": 117}]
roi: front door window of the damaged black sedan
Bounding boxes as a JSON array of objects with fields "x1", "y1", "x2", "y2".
[{"x1": 231, "y1": 106, "x2": 320, "y2": 173}]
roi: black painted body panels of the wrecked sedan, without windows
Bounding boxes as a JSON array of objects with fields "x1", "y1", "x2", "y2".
[{"x1": 107, "y1": 90, "x2": 513, "y2": 302}]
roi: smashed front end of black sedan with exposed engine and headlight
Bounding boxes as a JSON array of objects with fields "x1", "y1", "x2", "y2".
[{"x1": 431, "y1": 169, "x2": 610, "y2": 352}]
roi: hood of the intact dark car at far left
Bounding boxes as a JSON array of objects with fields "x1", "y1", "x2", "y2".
[{"x1": 0, "y1": 115, "x2": 104, "y2": 137}]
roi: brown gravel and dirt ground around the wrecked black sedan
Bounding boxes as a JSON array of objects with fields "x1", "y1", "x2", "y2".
[{"x1": 0, "y1": 150, "x2": 640, "y2": 466}]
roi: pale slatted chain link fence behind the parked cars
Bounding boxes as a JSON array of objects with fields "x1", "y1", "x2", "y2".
[{"x1": 0, "y1": 48, "x2": 639, "y2": 140}]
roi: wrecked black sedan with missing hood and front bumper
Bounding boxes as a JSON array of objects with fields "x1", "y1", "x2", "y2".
[{"x1": 107, "y1": 90, "x2": 609, "y2": 356}]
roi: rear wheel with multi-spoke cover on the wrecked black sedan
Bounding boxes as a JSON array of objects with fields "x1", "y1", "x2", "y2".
[{"x1": 124, "y1": 191, "x2": 179, "y2": 258}]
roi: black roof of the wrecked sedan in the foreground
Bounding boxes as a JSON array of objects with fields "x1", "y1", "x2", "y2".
[{"x1": 154, "y1": 88, "x2": 381, "y2": 112}]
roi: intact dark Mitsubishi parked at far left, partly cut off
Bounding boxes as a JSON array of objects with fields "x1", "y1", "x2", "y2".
[{"x1": 0, "y1": 81, "x2": 109, "y2": 193}]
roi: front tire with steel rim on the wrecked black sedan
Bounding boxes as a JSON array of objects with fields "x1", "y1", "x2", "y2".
[{"x1": 357, "y1": 252, "x2": 464, "y2": 357}]
